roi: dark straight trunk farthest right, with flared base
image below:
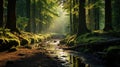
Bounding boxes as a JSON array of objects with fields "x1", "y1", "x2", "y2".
[{"x1": 104, "y1": 0, "x2": 113, "y2": 31}]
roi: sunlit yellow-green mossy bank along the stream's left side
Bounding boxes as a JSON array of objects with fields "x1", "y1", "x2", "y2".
[{"x1": 0, "y1": 29, "x2": 51, "y2": 51}]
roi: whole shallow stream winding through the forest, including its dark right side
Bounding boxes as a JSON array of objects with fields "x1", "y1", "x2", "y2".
[{"x1": 44, "y1": 39, "x2": 105, "y2": 67}]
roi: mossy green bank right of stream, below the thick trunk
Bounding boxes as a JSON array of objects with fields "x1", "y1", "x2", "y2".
[{"x1": 61, "y1": 33, "x2": 107, "y2": 46}]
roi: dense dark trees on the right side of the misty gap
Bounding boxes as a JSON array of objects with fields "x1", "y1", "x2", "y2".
[{"x1": 63, "y1": 0, "x2": 120, "y2": 34}]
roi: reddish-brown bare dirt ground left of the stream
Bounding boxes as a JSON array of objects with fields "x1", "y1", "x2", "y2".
[{"x1": 0, "y1": 47, "x2": 61, "y2": 67}]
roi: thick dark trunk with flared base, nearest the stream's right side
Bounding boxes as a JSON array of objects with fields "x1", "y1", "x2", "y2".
[{"x1": 78, "y1": 0, "x2": 89, "y2": 35}]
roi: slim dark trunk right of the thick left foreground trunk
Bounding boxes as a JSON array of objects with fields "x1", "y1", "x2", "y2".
[{"x1": 26, "y1": 0, "x2": 31, "y2": 32}]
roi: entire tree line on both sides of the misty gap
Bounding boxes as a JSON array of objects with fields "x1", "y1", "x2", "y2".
[{"x1": 0, "y1": 0, "x2": 120, "y2": 34}]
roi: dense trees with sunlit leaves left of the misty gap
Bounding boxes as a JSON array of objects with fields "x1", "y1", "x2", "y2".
[{"x1": 0, "y1": 0, "x2": 58, "y2": 33}]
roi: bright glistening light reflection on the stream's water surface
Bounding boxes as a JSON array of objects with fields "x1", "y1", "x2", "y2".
[{"x1": 46, "y1": 40, "x2": 89, "y2": 67}]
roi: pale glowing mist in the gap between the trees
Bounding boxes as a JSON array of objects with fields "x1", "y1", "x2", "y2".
[{"x1": 48, "y1": 6, "x2": 69, "y2": 34}]
